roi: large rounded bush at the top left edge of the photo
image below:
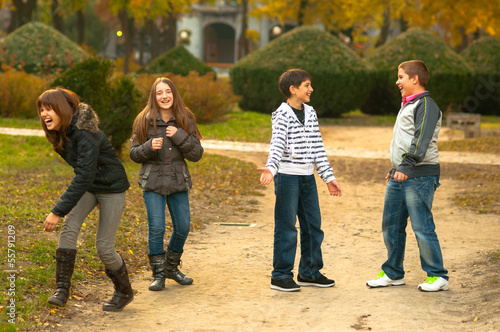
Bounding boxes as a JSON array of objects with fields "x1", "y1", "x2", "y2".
[{"x1": 0, "y1": 22, "x2": 88, "y2": 74}]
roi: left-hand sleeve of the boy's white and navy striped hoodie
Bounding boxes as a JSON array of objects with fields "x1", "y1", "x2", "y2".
[{"x1": 266, "y1": 110, "x2": 288, "y2": 176}]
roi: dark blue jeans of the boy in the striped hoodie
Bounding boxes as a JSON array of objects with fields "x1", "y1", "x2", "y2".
[{"x1": 272, "y1": 173, "x2": 324, "y2": 280}]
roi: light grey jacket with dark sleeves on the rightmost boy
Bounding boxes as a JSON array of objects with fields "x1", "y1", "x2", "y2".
[{"x1": 390, "y1": 91, "x2": 442, "y2": 178}]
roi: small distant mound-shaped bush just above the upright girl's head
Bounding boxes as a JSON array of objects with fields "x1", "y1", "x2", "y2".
[{"x1": 138, "y1": 45, "x2": 215, "y2": 76}]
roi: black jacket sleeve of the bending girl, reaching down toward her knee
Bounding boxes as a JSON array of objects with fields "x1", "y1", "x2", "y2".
[{"x1": 52, "y1": 130, "x2": 99, "y2": 217}]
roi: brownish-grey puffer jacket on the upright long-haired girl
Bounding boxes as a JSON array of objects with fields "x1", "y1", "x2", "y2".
[{"x1": 130, "y1": 117, "x2": 203, "y2": 195}]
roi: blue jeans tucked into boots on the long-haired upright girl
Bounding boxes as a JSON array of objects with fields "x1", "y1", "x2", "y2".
[{"x1": 146, "y1": 191, "x2": 191, "y2": 255}]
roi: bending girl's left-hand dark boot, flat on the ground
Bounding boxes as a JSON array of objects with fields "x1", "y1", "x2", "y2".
[{"x1": 48, "y1": 248, "x2": 76, "y2": 307}]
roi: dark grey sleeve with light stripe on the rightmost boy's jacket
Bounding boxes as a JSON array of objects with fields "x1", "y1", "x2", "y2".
[{"x1": 397, "y1": 97, "x2": 441, "y2": 174}]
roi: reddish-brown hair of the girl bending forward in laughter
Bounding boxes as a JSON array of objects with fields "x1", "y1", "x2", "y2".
[{"x1": 36, "y1": 88, "x2": 80, "y2": 152}]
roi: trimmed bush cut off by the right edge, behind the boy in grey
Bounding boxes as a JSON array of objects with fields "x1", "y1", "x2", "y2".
[{"x1": 461, "y1": 36, "x2": 500, "y2": 115}]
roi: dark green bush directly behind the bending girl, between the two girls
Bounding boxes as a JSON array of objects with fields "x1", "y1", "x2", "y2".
[{"x1": 52, "y1": 58, "x2": 141, "y2": 154}]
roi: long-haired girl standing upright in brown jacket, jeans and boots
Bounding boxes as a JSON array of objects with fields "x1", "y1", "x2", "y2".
[{"x1": 130, "y1": 78, "x2": 203, "y2": 291}]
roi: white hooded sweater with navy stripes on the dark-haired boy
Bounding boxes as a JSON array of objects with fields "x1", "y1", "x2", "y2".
[{"x1": 266, "y1": 103, "x2": 335, "y2": 183}]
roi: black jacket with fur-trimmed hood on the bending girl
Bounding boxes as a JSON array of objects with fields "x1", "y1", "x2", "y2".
[{"x1": 52, "y1": 103, "x2": 130, "y2": 217}]
